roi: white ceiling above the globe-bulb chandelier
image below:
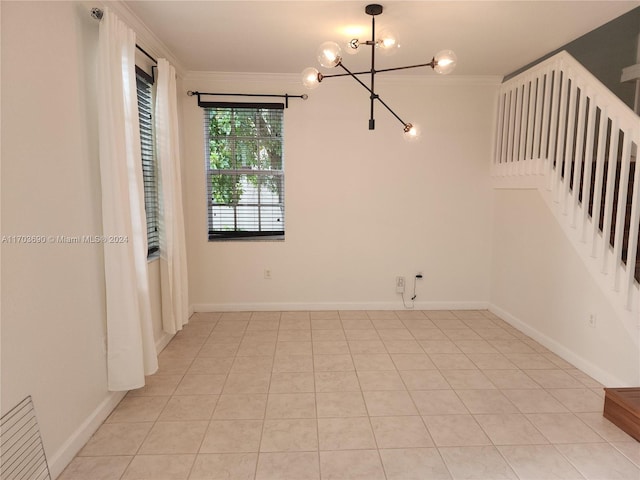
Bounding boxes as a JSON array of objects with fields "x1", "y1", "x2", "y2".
[{"x1": 124, "y1": 0, "x2": 640, "y2": 75}]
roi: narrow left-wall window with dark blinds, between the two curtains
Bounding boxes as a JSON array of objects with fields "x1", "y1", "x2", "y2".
[{"x1": 136, "y1": 67, "x2": 160, "y2": 256}]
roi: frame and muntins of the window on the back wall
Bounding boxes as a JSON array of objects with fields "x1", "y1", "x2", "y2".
[{"x1": 199, "y1": 102, "x2": 286, "y2": 242}]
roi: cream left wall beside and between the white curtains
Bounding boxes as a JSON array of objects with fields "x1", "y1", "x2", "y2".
[{"x1": 0, "y1": 1, "x2": 163, "y2": 477}]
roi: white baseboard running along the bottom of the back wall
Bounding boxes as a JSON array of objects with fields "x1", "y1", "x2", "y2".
[{"x1": 190, "y1": 301, "x2": 489, "y2": 313}]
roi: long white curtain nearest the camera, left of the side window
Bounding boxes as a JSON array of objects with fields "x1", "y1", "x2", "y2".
[{"x1": 98, "y1": 9, "x2": 158, "y2": 391}]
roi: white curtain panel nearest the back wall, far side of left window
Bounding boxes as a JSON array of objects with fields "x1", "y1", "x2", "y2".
[{"x1": 155, "y1": 58, "x2": 189, "y2": 334}]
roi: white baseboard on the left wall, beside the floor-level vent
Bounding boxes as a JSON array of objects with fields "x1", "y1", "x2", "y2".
[{"x1": 48, "y1": 392, "x2": 127, "y2": 479}]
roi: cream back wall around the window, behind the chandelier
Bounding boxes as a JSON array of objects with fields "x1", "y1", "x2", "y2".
[{"x1": 181, "y1": 71, "x2": 496, "y2": 310}]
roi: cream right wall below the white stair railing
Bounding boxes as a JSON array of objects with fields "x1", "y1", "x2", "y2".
[{"x1": 491, "y1": 190, "x2": 640, "y2": 387}]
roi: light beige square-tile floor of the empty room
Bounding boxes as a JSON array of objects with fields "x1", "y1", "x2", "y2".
[{"x1": 60, "y1": 311, "x2": 640, "y2": 480}]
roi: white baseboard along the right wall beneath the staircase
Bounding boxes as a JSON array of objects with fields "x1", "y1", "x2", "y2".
[{"x1": 489, "y1": 304, "x2": 632, "y2": 387}]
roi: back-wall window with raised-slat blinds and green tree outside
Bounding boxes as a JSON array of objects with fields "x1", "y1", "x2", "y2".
[{"x1": 205, "y1": 102, "x2": 284, "y2": 240}]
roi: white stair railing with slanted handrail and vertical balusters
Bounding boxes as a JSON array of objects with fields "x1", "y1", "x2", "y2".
[{"x1": 492, "y1": 52, "x2": 640, "y2": 328}]
